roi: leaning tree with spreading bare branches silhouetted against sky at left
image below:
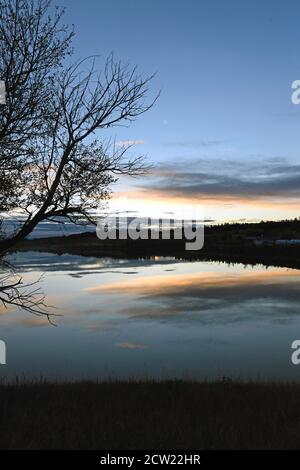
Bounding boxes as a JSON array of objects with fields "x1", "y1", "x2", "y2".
[{"x1": 0, "y1": 0, "x2": 157, "y2": 250}]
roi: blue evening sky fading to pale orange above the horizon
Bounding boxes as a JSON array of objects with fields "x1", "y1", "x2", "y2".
[{"x1": 54, "y1": 0, "x2": 300, "y2": 222}]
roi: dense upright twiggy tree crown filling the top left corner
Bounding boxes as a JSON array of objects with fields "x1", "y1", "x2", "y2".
[{"x1": 0, "y1": 0, "x2": 73, "y2": 203}]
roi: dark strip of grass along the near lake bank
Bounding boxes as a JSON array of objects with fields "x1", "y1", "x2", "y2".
[{"x1": 0, "y1": 381, "x2": 300, "y2": 450}]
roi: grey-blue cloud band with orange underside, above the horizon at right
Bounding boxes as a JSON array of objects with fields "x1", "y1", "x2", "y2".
[{"x1": 139, "y1": 158, "x2": 300, "y2": 198}]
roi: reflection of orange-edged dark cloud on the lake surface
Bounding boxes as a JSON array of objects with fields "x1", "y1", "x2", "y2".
[{"x1": 84, "y1": 267, "x2": 300, "y2": 326}]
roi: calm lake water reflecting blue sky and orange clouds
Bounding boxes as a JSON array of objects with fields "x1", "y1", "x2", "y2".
[{"x1": 0, "y1": 253, "x2": 300, "y2": 380}]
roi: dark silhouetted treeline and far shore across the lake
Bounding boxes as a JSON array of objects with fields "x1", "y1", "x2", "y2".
[{"x1": 16, "y1": 219, "x2": 300, "y2": 269}]
